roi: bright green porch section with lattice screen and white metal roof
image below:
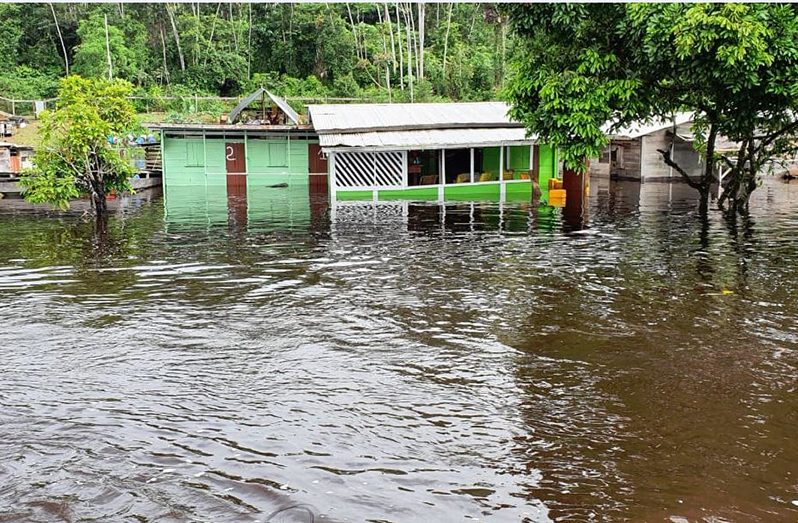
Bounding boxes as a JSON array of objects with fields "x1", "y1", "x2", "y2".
[{"x1": 308, "y1": 102, "x2": 557, "y2": 200}]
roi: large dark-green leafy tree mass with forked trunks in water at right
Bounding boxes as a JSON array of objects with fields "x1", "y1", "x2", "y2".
[{"x1": 508, "y1": 4, "x2": 798, "y2": 212}]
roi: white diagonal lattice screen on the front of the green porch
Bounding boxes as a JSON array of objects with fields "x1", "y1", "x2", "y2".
[{"x1": 333, "y1": 151, "x2": 405, "y2": 189}]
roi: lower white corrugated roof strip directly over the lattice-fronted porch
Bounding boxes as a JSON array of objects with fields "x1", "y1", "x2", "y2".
[{"x1": 319, "y1": 127, "x2": 535, "y2": 150}]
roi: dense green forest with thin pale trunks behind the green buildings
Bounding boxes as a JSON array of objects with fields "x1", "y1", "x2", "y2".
[{"x1": 0, "y1": 3, "x2": 511, "y2": 106}]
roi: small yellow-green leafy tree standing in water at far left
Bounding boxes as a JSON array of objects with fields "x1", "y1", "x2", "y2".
[{"x1": 20, "y1": 75, "x2": 138, "y2": 215}]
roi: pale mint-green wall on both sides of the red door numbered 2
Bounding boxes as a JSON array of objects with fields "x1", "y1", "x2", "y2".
[{"x1": 162, "y1": 136, "x2": 318, "y2": 186}]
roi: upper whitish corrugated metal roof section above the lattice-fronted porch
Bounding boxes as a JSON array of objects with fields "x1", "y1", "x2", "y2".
[{"x1": 308, "y1": 102, "x2": 521, "y2": 134}]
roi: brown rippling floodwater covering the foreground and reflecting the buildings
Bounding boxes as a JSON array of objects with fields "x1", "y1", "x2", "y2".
[{"x1": 0, "y1": 180, "x2": 798, "y2": 523}]
